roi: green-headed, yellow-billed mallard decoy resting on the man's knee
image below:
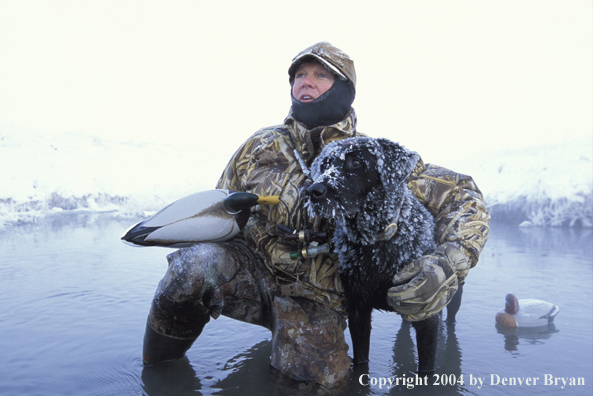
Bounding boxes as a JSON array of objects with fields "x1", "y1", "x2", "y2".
[{"x1": 121, "y1": 190, "x2": 280, "y2": 248}]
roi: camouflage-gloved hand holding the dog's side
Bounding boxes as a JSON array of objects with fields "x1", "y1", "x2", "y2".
[{"x1": 387, "y1": 245, "x2": 469, "y2": 322}]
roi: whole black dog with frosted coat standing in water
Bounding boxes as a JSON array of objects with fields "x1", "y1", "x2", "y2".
[{"x1": 308, "y1": 138, "x2": 446, "y2": 373}]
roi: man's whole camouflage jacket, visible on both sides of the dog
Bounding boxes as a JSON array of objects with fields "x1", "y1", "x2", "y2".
[{"x1": 217, "y1": 110, "x2": 490, "y2": 312}]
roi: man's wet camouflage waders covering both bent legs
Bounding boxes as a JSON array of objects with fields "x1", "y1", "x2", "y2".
[{"x1": 143, "y1": 242, "x2": 351, "y2": 387}]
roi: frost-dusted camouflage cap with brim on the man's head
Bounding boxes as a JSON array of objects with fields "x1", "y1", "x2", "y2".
[{"x1": 288, "y1": 41, "x2": 356, "y2": 87}]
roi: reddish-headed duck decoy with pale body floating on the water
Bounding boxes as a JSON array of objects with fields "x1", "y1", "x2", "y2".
[{"x1": 496, "y1": 293, "x2": 560, "y2": 327}]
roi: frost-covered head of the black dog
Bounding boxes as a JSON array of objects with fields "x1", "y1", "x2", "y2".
[{"x1": 308, "y1": 137, "x2": 419, "y2": 220}]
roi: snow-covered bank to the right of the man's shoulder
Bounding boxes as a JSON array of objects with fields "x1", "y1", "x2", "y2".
[{"x1": 451, "y1": 137, "x2": 593, "y2": 227}]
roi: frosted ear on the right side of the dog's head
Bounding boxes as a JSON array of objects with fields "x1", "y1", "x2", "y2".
[{"x1": 377, "y1": 138, "x2": 420, "y2": 189}]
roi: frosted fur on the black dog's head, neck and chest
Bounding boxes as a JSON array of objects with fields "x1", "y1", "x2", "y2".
[{"x1": 310, "y1": 138, "x2": 436, "y2": 271}]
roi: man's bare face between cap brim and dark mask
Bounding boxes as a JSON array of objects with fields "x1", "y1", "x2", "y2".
[{"x1": 292, "y1": 61, "x2": 335, "y2": 103}]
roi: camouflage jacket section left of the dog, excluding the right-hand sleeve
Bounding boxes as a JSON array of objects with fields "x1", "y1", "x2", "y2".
[{"x1": 217, "y1": 110, "x2": 356, "y2": 312}]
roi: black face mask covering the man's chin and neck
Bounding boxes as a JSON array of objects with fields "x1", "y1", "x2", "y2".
[{"x1": 290, "y1": 78, "x2": 354, "y2": 129}]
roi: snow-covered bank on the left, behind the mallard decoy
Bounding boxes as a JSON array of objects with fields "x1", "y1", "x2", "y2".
[{"x1": 0, "y1": 128, "x2": 213, "y2": 229}]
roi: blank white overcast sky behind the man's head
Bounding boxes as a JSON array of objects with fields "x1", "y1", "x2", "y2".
[{"x1": 0, "y1": 0, "x2": 593, "y2": 166}]
